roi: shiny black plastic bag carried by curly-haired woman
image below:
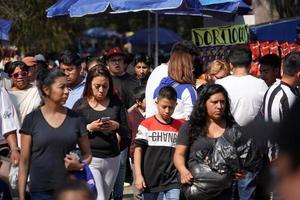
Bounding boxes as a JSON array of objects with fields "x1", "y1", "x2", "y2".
[{"x1": 182, "y1": 126, "x2": 261, "y2": 200}]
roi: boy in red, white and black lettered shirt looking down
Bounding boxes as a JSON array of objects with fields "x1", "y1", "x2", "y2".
[{"x1": 134, "y1": 86, "x2": 184, "y2": 200}]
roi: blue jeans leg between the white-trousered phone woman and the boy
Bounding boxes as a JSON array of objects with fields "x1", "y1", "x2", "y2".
[{"x1": 113, "y1": 148, "x2": 128, "y2": 198}]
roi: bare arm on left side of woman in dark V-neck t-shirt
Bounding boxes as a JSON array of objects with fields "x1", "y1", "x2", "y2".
[{"x1": 18, "y1": 134, "x2": 32, "y2": 200}]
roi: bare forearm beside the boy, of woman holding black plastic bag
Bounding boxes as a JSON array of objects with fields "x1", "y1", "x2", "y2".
[{"x1": 173, "y1": 145, "x2": 193, "y2": 184}]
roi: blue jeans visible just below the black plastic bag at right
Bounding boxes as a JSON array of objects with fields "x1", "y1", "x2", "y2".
[{"x1": 238, "y1": 172, "x2": 257, "y2": 200}]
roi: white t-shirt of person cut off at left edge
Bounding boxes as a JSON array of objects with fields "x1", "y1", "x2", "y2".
[{"x1": 0, "y1": 87, "x2": 20, "y2": 144}]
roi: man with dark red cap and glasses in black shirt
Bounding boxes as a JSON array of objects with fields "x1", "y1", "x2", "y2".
[{"x1": 106, "y1": 47, "x2": 137, "y2": 109}]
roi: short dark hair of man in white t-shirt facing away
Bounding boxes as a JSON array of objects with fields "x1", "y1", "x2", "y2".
[{"x1": 228, "y1": 45, "x2": 252, "y2": 67}]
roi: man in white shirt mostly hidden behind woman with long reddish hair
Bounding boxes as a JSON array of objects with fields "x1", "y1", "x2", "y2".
[{"x1": 146, "y1": 40, "x2": 197, "y2": 118}]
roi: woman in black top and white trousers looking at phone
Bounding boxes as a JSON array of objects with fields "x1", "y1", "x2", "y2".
[{"x1": 73, "y1": 65, "x2": 129, "y2": 200}]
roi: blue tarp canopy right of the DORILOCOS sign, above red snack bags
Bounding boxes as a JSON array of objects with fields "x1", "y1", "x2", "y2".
[{"x1": 250, "y1": 18, "x2": 300, "y2": 42}]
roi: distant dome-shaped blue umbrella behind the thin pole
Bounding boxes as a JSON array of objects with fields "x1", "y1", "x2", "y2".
[{"x1": 127, "y1": 27, "x2": 182, "y2": 45}]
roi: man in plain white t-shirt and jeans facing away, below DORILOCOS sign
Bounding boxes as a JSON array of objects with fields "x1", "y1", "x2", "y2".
[{"x1": 216, "y1": 46, "x2": 268, "y2": 200}]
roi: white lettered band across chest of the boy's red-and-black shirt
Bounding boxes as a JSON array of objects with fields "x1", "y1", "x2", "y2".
[{"x1": 147, "y1": 131, "x2": 178, "y2": 147}]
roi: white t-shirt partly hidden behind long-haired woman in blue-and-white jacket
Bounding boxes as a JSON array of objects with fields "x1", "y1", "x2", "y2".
[{"x1": 145, "y1": 63, "x2": 168, "y2": 118}]
